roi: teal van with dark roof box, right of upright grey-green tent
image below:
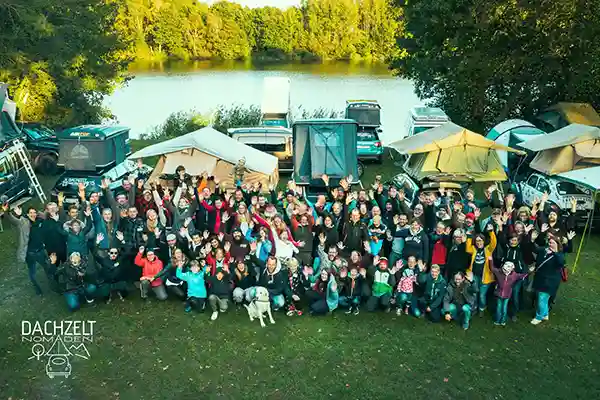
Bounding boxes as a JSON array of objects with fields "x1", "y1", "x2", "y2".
[{"x1": 345, "y1": 100, "x2": 383, "y2": 163}]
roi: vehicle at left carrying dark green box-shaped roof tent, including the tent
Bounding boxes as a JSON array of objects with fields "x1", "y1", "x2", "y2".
[{"x1": 51, "y1": 125, "x2": 152, "y2": 205}]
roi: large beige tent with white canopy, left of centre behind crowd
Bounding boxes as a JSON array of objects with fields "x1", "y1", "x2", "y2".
[{"x1": 130, "y1": 127, "x2": 279, "y2": 187}]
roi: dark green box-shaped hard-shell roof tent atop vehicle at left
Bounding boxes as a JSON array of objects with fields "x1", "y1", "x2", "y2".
[{"x1": 57, "y1": 125, "x2": 131, "y2": 172}]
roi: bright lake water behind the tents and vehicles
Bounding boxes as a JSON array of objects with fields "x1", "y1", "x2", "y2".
[{"x1": 105, "y1": 62, "x2": 421, "y2": 143}]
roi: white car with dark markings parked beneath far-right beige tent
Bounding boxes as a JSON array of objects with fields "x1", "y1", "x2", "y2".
[{"x1": 517, "y1": 172, "x2": 594, "y2": 226}]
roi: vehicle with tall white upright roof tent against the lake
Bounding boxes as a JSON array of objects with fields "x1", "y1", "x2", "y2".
[{"x1": 260, "y1": 77, "x2": 292, "y2": 129}]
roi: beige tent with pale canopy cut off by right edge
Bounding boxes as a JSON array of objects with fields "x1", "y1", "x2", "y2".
[{"x1": 521, "y1": 124, "x2": 600, "y2": 175}]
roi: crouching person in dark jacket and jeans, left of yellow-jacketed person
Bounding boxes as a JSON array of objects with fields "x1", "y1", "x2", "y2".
[{"x1": 444, "y1": 271, "x2": 477, "y2": 330}]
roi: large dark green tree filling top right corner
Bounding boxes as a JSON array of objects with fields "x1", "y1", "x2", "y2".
[{"x1": 392, "y1": 0, "x2": 600, "y2": 132}]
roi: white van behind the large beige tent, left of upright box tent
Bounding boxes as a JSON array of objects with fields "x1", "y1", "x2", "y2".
[{"x1": 228, "y1": 126, "x2": 294, "y2": 173}]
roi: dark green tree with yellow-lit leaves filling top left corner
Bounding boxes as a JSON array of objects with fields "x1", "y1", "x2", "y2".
[{"x1": 0, "y1": 0, "x2": 133, "y2": 125}]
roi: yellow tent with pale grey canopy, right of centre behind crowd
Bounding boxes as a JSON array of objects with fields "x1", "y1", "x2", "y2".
[{"x1": 390, "y1": 122, "x2": 524, "y2": 182}]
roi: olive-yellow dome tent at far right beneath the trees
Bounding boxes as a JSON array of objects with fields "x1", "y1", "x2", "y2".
[{"x1": 535, "y1": 103, "x2": 600, "y2": 132}]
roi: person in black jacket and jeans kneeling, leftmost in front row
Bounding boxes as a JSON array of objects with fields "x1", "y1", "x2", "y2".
[{"x1": 50, "y1": 253, "x2": 96, "y2": 311}]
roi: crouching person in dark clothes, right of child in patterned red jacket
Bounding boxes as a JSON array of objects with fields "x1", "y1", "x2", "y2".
[{"x1": 411, "y1": 264, "x2": 446, "y2": 322}]
